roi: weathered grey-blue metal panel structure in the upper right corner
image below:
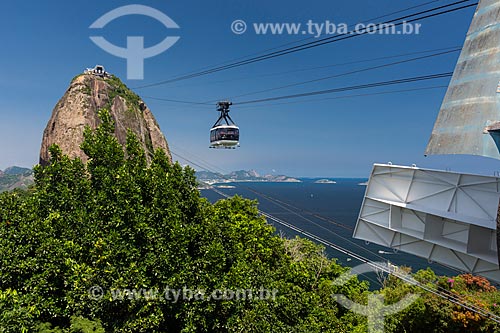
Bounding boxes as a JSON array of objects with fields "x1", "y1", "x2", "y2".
[{"x1": 425, "y1": 0, "x2": 500, "y2": 158}]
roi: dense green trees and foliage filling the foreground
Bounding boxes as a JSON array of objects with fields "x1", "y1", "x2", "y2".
[{"x1": 0, "y1": 111, "x2": 500, "y2": 333}]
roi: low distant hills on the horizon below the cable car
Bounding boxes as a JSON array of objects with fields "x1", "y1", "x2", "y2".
[{"x1": 196, "y1": 170, "x2": 301, "y2": 185}]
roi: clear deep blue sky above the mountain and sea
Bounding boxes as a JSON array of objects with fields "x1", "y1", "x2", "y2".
[{"x1": 0, "y1": 0, "x2": 500, "y2": 177}]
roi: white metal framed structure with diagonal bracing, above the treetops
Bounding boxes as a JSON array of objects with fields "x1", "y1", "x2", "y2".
[{"x1": 353, "y1": 164, "x2": 500, "y2": 282}]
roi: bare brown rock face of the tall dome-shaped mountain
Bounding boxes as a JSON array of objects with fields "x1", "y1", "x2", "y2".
[{"x1": 40, "y1": 74, "x2": 172, "y2": 165}]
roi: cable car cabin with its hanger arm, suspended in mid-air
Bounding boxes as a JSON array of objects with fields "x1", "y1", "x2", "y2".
[{"x1": 210, "y1": 101, "x2": 240, "y2": 149}]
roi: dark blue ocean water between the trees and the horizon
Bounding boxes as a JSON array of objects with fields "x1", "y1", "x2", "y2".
[{"x1": 201, "y1": 178, "x2": 457, "y2": 285}]
